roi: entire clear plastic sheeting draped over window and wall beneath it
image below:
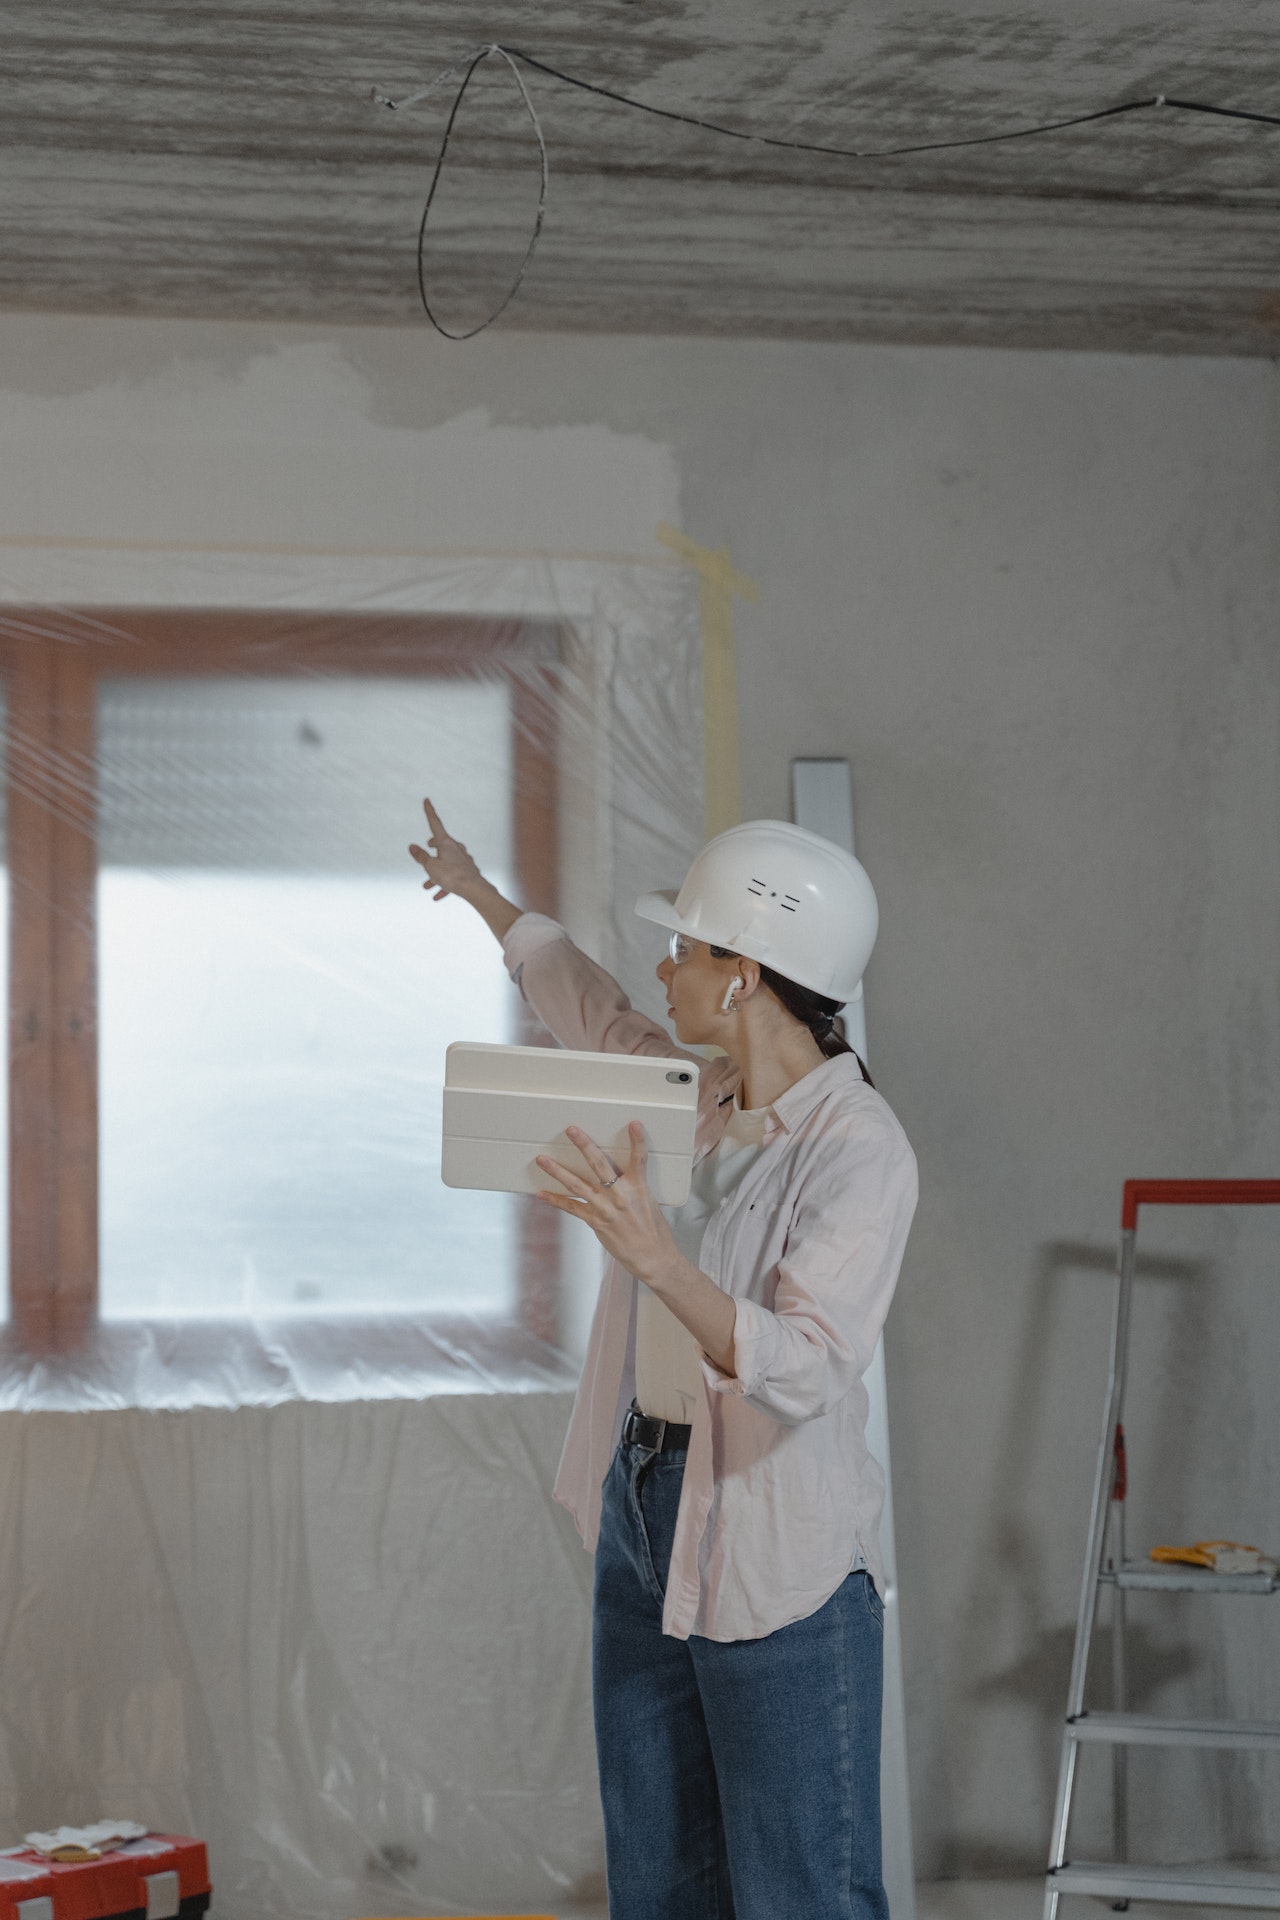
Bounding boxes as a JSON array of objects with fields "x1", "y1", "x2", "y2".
[{"x1": 0, "y1": 561, "x2": 702, "y2": 1920}]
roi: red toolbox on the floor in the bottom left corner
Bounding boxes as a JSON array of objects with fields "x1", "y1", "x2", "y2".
[{"x1": 0, "y1": 1834, "x2": 209, "y2": 1920}]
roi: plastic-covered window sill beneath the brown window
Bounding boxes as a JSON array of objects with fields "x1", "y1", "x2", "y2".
[{"x1": 0, "y1": 1313, "x2": 578, "y2": 1413}]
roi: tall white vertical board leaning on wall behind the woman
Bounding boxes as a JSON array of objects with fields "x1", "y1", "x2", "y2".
[{"x1": 791, "y1": 760, "x2": 915, "y2": 1920}]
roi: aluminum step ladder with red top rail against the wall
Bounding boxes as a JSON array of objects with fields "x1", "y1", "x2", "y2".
[{"x1": 1044, "y1": 1181, "x2": 1280, "y2": 1920}]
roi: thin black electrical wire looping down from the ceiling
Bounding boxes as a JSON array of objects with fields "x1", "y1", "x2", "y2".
[{"x1": 374, "y1": 40, "x2": 1280, "y2": 340}]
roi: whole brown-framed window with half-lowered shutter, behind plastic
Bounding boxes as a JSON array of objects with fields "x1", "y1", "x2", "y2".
[{"x1": 4, "y1": 612, "x2": 557, "y2": 1352}]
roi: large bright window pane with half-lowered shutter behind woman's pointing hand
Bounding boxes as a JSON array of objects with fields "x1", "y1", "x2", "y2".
[{"x1": 98, "y1": 680, "x2": 516, "y2": 1319}]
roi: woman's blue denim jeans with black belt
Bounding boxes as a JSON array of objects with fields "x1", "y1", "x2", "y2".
[{"x1": 593, "y1": 1446, "x2": 889, "y2": 1920}]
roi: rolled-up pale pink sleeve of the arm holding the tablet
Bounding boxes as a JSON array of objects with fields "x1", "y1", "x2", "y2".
[{"x1": 704, "y1": 1116, "x2": 917, "y2": 1427}]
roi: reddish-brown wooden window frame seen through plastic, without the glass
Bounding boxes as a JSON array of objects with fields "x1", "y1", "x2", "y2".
[{"x1": 0, "y1": 609, "x2": 560, "y2": 1357}]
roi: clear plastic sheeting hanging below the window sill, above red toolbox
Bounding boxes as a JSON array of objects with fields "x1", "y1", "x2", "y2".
[{"x1": 0, "y1": 1394, "x2": 601, "y2": 1920}]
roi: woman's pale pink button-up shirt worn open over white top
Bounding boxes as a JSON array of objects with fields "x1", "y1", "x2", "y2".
[{"x1": 505, "y1": 914, "x2": 917, "y2": 1640}]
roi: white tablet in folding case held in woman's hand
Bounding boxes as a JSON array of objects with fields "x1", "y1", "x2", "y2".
[{"x1": 439, "y1": 1041, "x2": 699, "y2": 1206}]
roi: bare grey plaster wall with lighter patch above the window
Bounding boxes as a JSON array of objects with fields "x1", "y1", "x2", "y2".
[{"x1": 0, "y1": 317, "x2": 1280, "y2": 1874}]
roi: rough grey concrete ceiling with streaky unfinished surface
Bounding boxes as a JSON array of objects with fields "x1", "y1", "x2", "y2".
[{"x1": 0, "y1": 0, "x2": 1280, "y2": 353}]
